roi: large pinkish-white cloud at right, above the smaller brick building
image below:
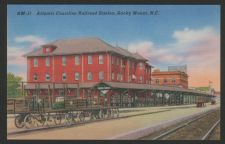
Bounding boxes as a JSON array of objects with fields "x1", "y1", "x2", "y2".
[{"x1": 128, "y1": 27, "x2": 220, "y2": 64}]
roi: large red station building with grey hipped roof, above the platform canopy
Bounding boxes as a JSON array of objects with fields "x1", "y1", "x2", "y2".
[{"x1": 25, "y1": 38, "x2": 151, "y2": 106}]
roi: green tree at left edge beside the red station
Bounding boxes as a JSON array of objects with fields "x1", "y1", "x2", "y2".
[{"x1": 7, "y1": 73, "x2": 23, "y2": 98}]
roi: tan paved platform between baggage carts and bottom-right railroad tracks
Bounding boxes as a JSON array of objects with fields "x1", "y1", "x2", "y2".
[{"x1": 8, "y1": 104, "x2": 219, "y2": 140}]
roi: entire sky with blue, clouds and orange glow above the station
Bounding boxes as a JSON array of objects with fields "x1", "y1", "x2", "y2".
[{"x1": 7, "y1": 5, "x2": 220, "y2": 90}]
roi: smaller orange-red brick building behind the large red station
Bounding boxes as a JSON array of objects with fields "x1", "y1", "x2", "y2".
[{"x1": 152, "y1": 70, "x2": 188, "y2": 89}]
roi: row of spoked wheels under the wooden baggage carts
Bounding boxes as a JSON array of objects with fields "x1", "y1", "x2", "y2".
[{"x1": 15, "y1": 107, "x2": 119, "y2": 129}]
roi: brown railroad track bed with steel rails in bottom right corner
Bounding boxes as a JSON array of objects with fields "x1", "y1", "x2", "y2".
[{"x1": 146, "y1": 109, "x2": 220, "y2": 140}]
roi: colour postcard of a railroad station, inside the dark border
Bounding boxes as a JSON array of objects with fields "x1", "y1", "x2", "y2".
[{"x1": 7, "y1": 4, "x2": 221, "y2": 140}]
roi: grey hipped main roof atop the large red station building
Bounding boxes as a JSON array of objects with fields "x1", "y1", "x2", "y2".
[{"x1": 24, "y1": 37, "x2": 147, "y2": 61}]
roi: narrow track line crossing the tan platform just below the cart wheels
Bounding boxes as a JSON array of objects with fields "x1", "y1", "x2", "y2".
[{"x1": 7, "y1": 109, "x2": 171, "y2": 136}]
